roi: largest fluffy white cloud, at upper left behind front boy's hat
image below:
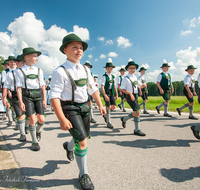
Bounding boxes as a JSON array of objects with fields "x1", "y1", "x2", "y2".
[{"x1": 0, "y1": 12, "x2": 91, "y2": 74}]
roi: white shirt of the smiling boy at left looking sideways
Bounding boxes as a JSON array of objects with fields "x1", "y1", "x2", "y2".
[{"x1": 15, "y1": 65, "x2": 45, "y2": 89}]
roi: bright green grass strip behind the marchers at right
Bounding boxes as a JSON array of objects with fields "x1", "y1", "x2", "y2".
[{"x1": 101, "y1": 96, "x2": 200, "y2": 113}]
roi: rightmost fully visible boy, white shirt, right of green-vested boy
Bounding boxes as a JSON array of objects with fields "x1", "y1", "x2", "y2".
[{"x1": 176, "y1": 65, "x2": 198, "y2": 120}]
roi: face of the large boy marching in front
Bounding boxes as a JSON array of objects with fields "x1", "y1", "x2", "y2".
[{"x1": 63, "y1": 41, "x2": 83, "y2": 63}]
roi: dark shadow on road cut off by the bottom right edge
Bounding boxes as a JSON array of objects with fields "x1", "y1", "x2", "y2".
[{"x1": 160, "y1": 166, "x2": 200, "y2": 182}]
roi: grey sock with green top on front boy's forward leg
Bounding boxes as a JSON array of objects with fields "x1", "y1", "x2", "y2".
[{"x1": 74, "y1": 148, "x2": 88, "y2": 177}]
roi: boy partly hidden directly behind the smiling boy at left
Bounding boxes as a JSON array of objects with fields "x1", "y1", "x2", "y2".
[{"x1": 3, "y1": 55, "x2": 27, "y2": 142}]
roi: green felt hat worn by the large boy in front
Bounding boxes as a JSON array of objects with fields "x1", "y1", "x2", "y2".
[{"x1": 60, "y1": 34, "x2": 88, "y2": 54}]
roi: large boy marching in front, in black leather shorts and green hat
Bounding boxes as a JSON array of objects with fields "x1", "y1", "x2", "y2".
[{"x1": 50, "y1": 34, "x2": 106, "y2": 190}]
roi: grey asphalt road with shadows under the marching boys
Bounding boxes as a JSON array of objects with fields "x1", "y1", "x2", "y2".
[{"x1": 0, "y1": 107, "x2": 200, "y2": 190}]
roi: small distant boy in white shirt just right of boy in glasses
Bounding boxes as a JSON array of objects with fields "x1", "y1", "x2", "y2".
[{"x1": 138, "y1": 67, "x2": 149, "y2": 114}]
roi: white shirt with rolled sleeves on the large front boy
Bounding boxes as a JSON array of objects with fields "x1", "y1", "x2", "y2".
[{"x1": 50, "y1": 60, "x2": 98, "y2": 103}]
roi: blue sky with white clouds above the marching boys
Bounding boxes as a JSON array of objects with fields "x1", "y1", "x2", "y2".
[{"x1": 0, "y1": 0, "x2": 200, "y2": 82}]
